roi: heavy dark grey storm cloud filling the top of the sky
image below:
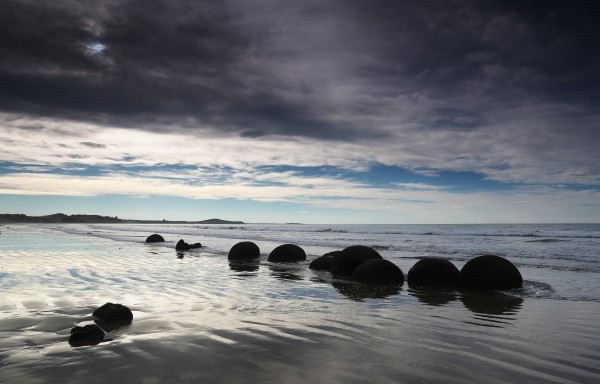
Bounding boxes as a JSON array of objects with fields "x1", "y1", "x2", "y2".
[{"x1": 0, "y1": 0, "x2": 600, "y2": 140}]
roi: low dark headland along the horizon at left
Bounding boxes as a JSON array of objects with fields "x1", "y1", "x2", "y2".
[{"x1": 0, "y1": 213, "x2": 245, "y2": 224}]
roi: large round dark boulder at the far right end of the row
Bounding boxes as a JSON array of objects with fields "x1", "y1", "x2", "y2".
[{"x1": 459, "y1": 255, "x2": 523, "y2": 289}]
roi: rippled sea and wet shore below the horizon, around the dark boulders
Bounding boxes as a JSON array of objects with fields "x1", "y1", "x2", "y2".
[{"x1": 0, "y1": 224, "x2": 600, "y2": 383}]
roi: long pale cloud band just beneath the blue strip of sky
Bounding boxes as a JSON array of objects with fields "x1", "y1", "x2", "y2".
[{"x1": 0, "y1": 173, "x2": 600, "y2": 223}]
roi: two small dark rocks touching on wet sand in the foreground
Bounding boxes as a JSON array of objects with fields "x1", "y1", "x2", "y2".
[{"x1": 69, "y1": 303, "x2": 133, "y2": 347}]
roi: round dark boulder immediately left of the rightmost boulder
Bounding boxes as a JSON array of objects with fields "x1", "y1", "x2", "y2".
[{"x1": 408, "y1": 257, "x2": 460, "y2": 286}]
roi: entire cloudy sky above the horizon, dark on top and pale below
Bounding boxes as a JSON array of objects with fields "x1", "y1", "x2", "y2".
[{"x1": 0, "y1": 0, "x2": 600, "y2": 224}]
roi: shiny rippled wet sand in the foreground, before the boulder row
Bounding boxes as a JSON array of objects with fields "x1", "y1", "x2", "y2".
[{"x1": 0, "y1": 226, "x2": 600, "y2": 383}]
